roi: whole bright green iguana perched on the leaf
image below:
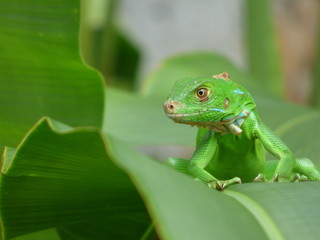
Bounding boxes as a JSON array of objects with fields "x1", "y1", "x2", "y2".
[{"x1": 164, "y1": 73, "x2": 320, "y2": 190}]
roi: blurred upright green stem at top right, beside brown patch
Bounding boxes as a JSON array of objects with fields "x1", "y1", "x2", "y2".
[{"x1": 245, "y1": 0, "x2": 284, "y2": 96}]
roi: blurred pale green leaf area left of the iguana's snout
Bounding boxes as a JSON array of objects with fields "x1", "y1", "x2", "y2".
[{"x1": 103, "y1": 88, "x2": 196, "y2": 145}]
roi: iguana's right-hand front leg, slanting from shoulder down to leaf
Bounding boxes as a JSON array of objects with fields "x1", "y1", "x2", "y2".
[{"x1": 255, "y1": 122, "x2": 295, "y2": 182}]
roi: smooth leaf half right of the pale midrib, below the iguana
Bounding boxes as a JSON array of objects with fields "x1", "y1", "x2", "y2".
[{"x1": 226, "y1": 182, "x2": 320, "y2": 240}]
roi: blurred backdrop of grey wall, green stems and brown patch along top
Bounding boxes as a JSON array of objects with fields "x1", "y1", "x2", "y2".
[{"x1": 81, "y1": 0, "x2": 320, "y2": 104}]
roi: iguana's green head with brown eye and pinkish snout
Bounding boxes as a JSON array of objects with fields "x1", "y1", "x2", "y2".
[{"x1": 164, "y1": 72, "x2": 255, "y2": 134}]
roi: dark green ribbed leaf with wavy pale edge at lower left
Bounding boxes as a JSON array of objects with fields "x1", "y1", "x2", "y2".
[{"x1": 0, "y1": 119, "x2": 148, "y2": 239}]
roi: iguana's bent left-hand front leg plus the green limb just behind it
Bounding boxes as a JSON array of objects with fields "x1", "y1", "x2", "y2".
[{"x1": 166, "y1": 130, "x2": 241, "y2": 190}]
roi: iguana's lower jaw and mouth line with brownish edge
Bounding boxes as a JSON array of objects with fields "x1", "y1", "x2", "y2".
[{"x1": 167, "y1": 109, "x2": 250, "y2": 135}]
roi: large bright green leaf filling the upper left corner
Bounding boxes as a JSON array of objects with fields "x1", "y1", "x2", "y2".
[{"x1": 0, "y1": 0, "x2": 104, "y2": 146}]
